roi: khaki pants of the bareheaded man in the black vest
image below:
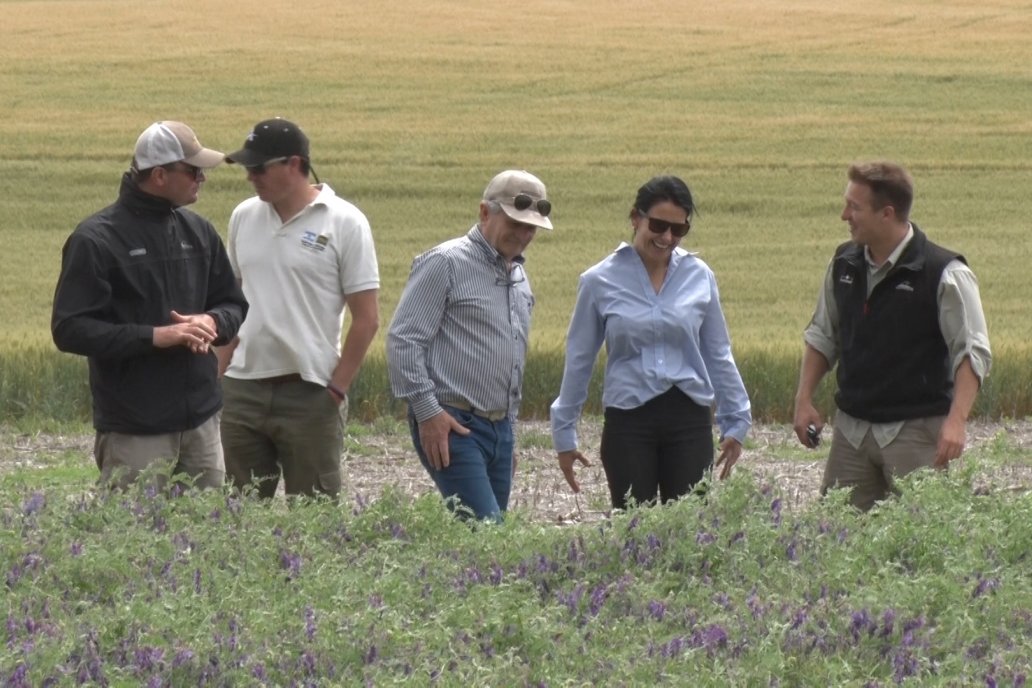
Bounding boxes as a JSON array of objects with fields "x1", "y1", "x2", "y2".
[{"x1": 820, "y1": 416, "x2": 945, "y2": 511}]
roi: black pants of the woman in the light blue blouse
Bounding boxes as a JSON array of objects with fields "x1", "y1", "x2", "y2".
[{"x1": 601, "y1": 387, "x2": 713, "y2": 509}]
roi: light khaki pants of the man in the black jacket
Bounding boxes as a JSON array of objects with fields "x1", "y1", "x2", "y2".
[{"x1": 93, "y1": 414, "x2": 226, "y2": 488}]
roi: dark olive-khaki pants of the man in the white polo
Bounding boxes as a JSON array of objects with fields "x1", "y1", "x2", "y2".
[{"x1": 222, "y1": 378, "x2": 348, "y2": 498}]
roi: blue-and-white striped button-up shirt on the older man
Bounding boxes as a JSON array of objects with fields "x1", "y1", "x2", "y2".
[{"x1": 387, "y1": 225, "x2": 534, "y2": 422}]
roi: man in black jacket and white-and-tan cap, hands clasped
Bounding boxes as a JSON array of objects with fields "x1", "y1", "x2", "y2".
[{"x1": 51, "y1": 121, "x2": 248, "y2": 487}]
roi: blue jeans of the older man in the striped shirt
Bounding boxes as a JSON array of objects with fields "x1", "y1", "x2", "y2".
[{"x1": 409, "y1": 405, "x2": 513, "y2": 521}]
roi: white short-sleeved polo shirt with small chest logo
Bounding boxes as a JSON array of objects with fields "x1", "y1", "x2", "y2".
[{"x1": 226, "y1": 184, "x2": 380, "y2": 385}]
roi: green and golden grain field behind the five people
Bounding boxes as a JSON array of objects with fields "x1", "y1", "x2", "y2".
[{"x1": 0, "y1": 0, "x2": 1032, "y2": 420}]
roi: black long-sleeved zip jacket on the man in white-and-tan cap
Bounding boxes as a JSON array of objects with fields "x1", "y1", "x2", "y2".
[{"x1": 51, "y1": 173, "x2": 248, "y2": 434}]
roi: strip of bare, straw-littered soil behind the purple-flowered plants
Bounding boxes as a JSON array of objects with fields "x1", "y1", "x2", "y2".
[{"x1": 0, "y1": 420, "x2": 1032, "y2": 524}]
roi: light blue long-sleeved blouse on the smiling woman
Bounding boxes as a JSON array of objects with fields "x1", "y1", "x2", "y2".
[{"x1": 551, "y1": 242, "x2": 752, "y2": 452}]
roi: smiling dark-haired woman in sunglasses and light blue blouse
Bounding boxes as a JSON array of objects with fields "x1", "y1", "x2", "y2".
[{"x1": 551, "y1": 176, "x2": 752, "y2": 509}]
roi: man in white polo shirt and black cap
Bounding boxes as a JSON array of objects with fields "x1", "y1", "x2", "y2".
[{"x1": 220, "y1": 119, "x2": 380, "y2": 497}]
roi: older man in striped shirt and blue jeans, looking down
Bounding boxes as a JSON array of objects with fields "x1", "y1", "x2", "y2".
[{"x1": 387, "y1": 170, "x2": 552, "y2": 520}]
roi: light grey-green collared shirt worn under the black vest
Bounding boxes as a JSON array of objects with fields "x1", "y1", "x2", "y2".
[{"x1": 803, "y1": 226, "x2": 993, "y2": 449}]
